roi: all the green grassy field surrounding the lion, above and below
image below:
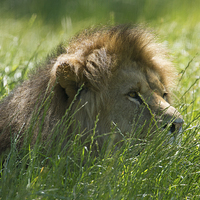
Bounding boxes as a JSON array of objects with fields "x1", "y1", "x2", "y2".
[{"x1": 0, "y1": 0, "x2": 200, "y2": 200}]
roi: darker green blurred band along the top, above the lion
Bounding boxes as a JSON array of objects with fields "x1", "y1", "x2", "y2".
[{"x1": 1, "y1": 0, "x2": 199, "y2": 27}]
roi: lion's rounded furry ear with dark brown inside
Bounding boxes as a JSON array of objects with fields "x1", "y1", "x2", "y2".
[{"x1": 54, "y1": 54, "x2": 85, "y2": 101}]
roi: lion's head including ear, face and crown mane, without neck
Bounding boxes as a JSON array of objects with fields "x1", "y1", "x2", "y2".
[{"x1": 51, "y1": 26, "x2": 183, "y2": 145}]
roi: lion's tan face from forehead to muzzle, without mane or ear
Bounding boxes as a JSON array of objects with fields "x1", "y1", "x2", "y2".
[{"x1": 96, "y1": 62, "x2": 183, "y2": 141}]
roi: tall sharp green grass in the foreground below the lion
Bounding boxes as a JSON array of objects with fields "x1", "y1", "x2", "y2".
[{"x1": 0, "y1": 101, "x2": 200, "y2": 199}]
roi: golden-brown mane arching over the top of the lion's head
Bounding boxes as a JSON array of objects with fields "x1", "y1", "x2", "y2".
[{"x1": 66, "y1": 25, "x2": 175, "y2": 93}]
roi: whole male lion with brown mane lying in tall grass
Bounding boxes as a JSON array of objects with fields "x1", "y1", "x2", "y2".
[{"x1": 0, "y1": 25, "x2": 183, "y2": 152}]
